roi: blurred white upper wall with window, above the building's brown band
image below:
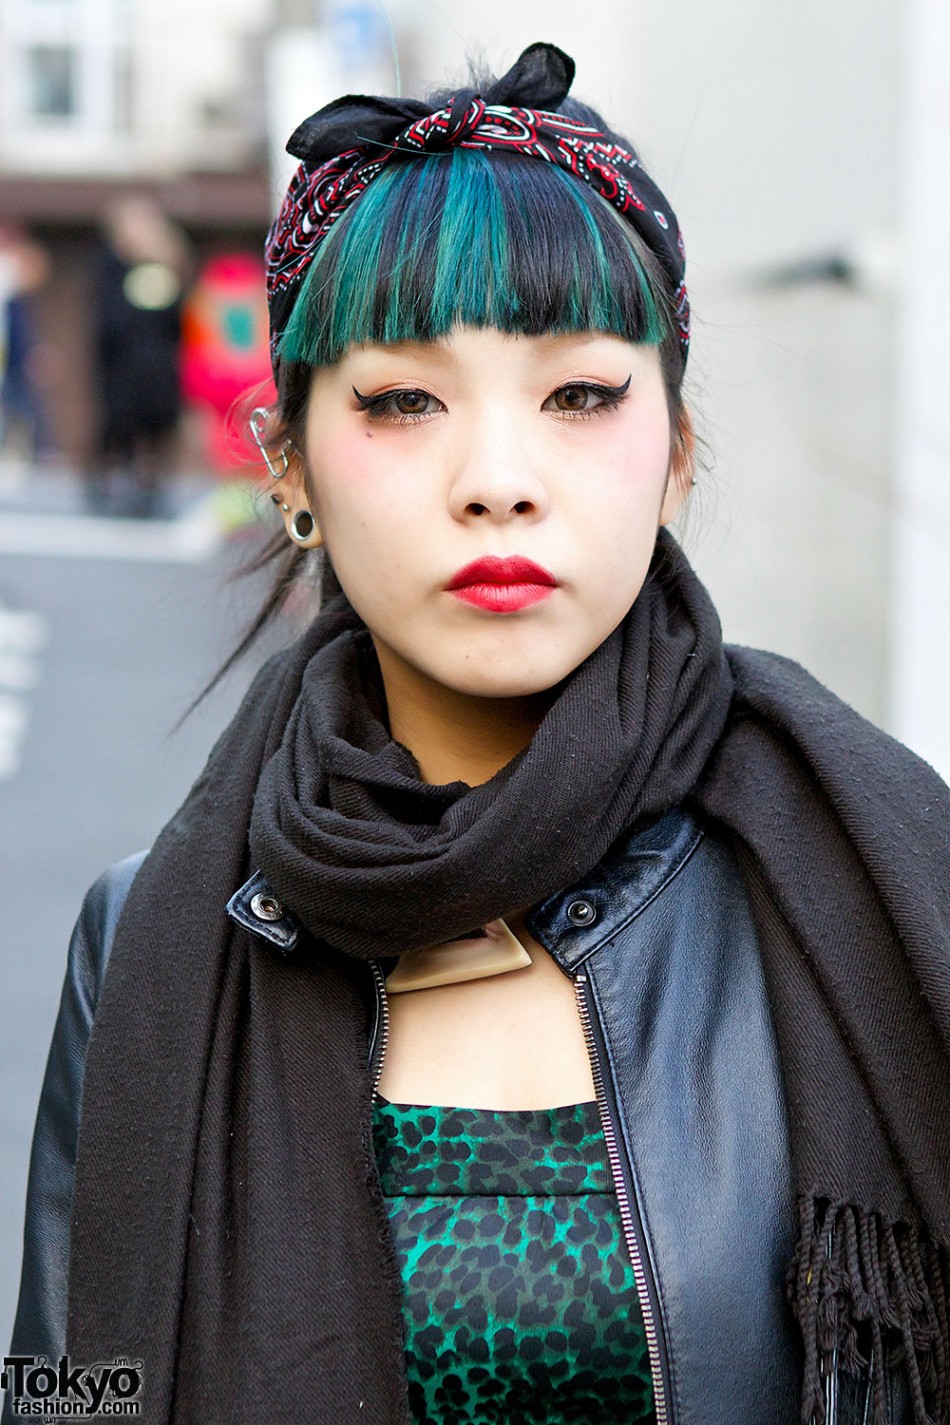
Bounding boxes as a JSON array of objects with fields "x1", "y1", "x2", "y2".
[{"x1": 0, "y1": 0, "x2": 272, "y2": 180}]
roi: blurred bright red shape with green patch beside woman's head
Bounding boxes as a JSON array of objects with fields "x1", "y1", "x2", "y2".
[{"x1": 181, "y1": 252, "x2": 276, "y2": 475}]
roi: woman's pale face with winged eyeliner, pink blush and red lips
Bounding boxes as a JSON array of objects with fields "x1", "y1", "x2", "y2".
[{"x1": 305, "y1": 328, "x2": 685, "y2": 697}]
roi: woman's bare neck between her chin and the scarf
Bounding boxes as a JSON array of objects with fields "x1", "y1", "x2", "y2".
[{"x1": 376, "y1": 644, "x2": 554, "y2": 787}]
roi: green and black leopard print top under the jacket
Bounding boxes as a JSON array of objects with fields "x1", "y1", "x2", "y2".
[{"x1": 373, "y1": 1096, "x2": 655, "y2": 1425}]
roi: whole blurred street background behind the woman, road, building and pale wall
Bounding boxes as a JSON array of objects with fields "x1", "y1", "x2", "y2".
[{"x1": 0, "y1": 0, "x2": 950, "y2": 1348}]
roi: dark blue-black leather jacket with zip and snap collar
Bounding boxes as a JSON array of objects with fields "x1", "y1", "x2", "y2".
[{"x1": 3, "y1": 812, "x2": 909, "y2": 1425}]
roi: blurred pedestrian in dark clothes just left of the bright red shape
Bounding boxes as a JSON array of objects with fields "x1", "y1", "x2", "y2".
[{"x1": 85, "y1": 198, "x2": 188, "y2": 519}]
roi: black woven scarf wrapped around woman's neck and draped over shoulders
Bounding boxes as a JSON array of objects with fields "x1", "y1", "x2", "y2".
[{"x1": 68, "y1": 534, "x2": 950, "y2": 1425}]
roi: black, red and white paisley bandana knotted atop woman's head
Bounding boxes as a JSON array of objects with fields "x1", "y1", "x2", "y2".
[{"x1": 265, "y1": 44, "x2": 689, "y2": 366}]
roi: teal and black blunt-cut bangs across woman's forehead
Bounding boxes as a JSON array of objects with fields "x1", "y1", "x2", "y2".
[{"x1": 279, "y1": 148, "x2": 672, "y2": 366}]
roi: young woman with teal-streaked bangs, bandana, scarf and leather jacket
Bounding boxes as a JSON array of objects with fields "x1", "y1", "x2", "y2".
[{"x1": 10, "y1": 44, "x2": 950, "y2": 1425}]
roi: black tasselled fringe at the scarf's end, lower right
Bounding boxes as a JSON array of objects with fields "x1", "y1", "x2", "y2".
[{"x1": 789, "y1": 1198, "x2": 950, "y2": 1425}]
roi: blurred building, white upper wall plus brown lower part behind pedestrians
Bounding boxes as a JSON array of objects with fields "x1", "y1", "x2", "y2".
[{"x1": 0, "y1": 0, "x2": 272, "y2": 463}]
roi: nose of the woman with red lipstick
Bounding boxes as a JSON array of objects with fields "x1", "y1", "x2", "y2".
[{"x1": 450, "y1": 415, "x2": 548, "y2": 523}]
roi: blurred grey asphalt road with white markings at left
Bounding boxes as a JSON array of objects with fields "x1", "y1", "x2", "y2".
[{"x1": 0, "y1": 470, "x2": 290, "y2": 1352}]
